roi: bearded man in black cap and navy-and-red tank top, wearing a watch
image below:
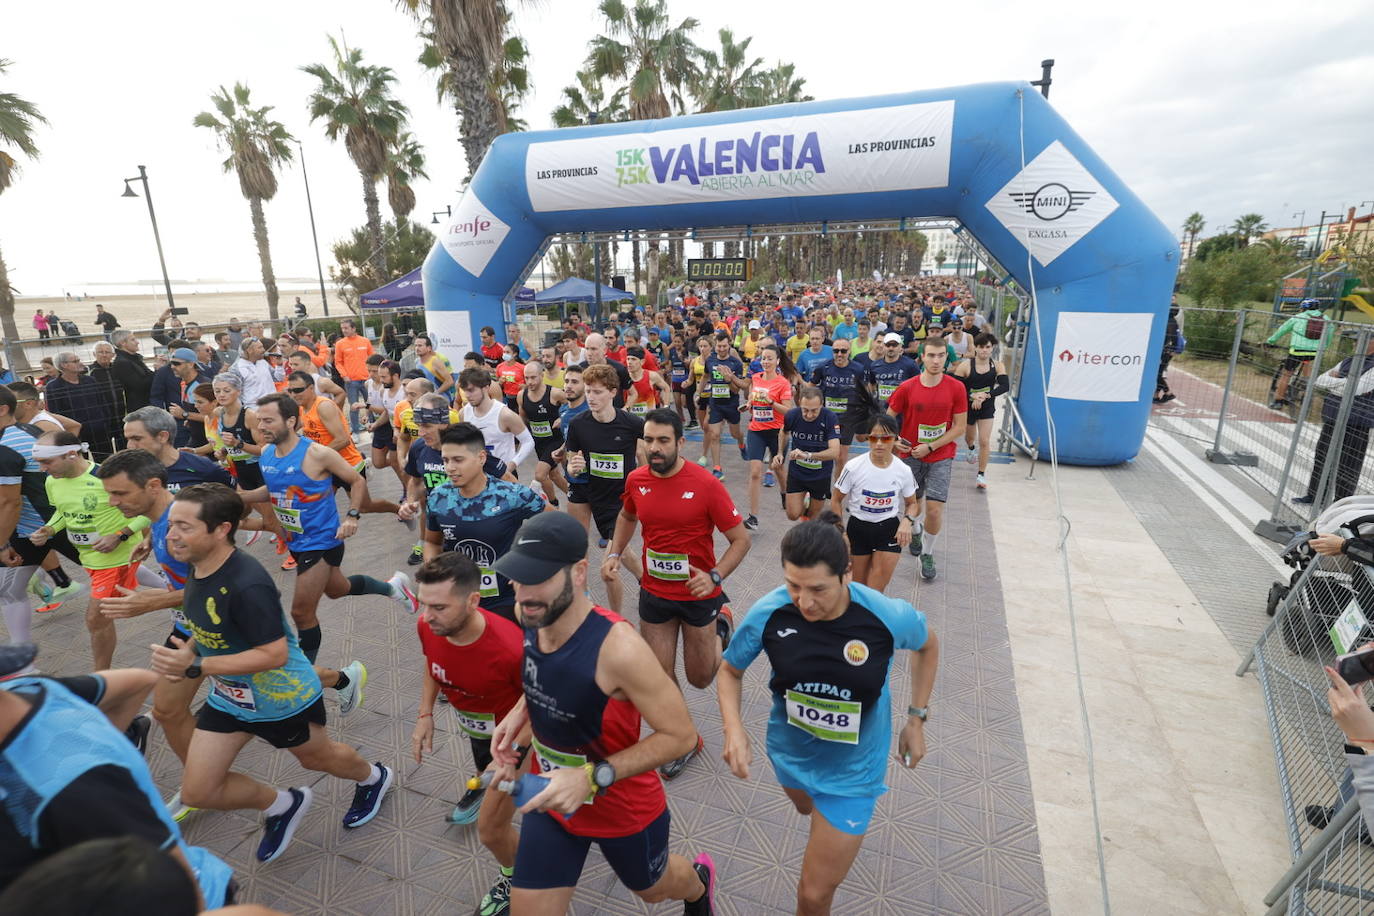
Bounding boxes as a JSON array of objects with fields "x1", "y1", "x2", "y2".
[{"x1": 492, "y1": 512, "x2": 716, "y2": 916}]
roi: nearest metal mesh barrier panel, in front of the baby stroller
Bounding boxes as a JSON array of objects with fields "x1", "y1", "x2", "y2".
[{"x1": 1237, "y1": 538, "x2": 1374, "y2": 916}]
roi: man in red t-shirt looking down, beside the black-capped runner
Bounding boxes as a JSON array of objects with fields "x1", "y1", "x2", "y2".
[{"x1": 411, "y1": 551, "x2": 529, "y2": 913}]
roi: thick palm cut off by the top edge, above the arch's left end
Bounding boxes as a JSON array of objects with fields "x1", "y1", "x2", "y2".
[{"x1": 397, "y1": 0, "x2": 529, "y2": 174}]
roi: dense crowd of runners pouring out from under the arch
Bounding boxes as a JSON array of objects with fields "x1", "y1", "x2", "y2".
[{"x1": 0, "y1": 271, "x2": 1007, "y2": 916}]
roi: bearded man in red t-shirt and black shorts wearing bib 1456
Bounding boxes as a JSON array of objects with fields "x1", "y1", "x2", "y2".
[{"x1": 602, "y1": 408, "x2": 749, "y2": 779}]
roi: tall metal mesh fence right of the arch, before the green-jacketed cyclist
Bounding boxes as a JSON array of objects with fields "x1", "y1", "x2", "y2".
[{"x1": 1150, "y1": 309, "x2": 1374, "y2": 541}]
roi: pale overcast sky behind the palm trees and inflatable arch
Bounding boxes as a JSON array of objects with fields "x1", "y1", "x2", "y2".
[{"x1": 0, "y1": 0, "x2": 1374, "y2": 295}]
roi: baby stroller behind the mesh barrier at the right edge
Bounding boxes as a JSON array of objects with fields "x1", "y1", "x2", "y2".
[{"x1": 1265, "y1": 496, "x2": 1374, "y2": 658}]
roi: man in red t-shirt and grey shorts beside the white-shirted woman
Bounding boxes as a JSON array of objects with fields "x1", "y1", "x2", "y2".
[{"x1": 888, "y1": 338, "x2": 969, "y2": 580}]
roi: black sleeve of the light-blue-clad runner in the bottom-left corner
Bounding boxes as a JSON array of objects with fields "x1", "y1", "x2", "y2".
[{"x1": 38, "y1": 764, "x2": 176, "y2": 849}]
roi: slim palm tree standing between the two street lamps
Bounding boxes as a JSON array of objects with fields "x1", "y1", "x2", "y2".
[{"x1": 191, "y1": 82, "x2": 294, "y2": 321}]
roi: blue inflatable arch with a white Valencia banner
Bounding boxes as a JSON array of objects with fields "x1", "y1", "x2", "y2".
[{"x1": 423, "y1": 82, "x2": 1178, "y2": 464}]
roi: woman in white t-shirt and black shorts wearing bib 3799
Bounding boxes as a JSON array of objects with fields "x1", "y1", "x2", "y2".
[{"x1": 830, "y1": 413, "x2": 921, "y2": 592}]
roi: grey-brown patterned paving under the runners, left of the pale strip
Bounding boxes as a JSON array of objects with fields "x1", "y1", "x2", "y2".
[{"x1": 21, "y1": 441, "x2": 1048, "y2": 916}]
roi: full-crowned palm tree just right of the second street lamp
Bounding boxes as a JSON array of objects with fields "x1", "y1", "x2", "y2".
[{"x1": 301, "y1": 36, "x2": 409, "y2": 276}]
